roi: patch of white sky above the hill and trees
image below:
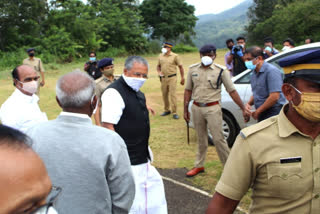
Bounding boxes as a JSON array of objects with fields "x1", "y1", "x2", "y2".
[{"x1": 186, "y1": 0, "x2": 244, "y2": 16}]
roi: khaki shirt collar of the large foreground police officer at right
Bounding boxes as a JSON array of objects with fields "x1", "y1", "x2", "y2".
[{"x1": 278, "y1": 104, "x2": 309, "y2": 137}]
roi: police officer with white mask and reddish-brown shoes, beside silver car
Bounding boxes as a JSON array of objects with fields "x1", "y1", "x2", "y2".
[{"x1": 184, "y1": 45, "x2": 249, "y2": 177}]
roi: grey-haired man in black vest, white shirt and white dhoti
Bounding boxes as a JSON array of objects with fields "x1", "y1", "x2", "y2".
[{"x1": 101, "y1": 56, "x2": 167, "y2": 214}]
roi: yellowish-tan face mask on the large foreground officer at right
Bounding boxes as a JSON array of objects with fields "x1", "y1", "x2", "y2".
[{"x1": 291, "y1": 85, "x2": 320, "y2": 122}]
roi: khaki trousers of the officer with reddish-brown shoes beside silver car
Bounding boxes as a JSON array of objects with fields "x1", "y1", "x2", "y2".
[{"x1": 191, "y1": 104, "x2": 230, "y2": 167}]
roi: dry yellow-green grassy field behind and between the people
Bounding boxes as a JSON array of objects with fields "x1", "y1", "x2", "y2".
[{"x1": 0, "y1": 50, "x2": 250, "y2": 209}]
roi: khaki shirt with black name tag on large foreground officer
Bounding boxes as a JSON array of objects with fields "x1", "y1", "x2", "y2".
[{"x1": 216, "y1": 105, "x2": 320, "y2": 214}]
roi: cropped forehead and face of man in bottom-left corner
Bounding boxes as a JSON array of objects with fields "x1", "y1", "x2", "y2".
[{"x1": 0, "y1": 125, "x2": 59, "y2": 214}]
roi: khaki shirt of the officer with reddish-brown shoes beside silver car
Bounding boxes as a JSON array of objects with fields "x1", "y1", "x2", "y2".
[{"x1": 185, "y1": 63, "x2": 235, "y2": 103}]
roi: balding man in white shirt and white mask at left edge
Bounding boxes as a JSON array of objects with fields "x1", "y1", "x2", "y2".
[{"x1": 0, "y1": 65, "x2": 48, "y2": 132}]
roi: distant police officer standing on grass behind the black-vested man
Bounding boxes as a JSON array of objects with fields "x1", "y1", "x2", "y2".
[{"x1": 157, "y1": 42, "x2": 184, "y2": 119}]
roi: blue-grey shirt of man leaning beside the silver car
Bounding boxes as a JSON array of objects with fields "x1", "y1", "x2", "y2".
[{"x1": 251, "y1": 62, "x2": 286, "y2": 109}]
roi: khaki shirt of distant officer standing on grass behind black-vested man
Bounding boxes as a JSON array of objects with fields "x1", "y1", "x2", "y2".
[{"x1": 158, "y1": 52, "x2": 182, "y2": 77}]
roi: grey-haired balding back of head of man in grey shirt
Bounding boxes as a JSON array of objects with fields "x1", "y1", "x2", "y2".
[{"x1": 56, "y1": 70, "x2": 96, "y2": 108}]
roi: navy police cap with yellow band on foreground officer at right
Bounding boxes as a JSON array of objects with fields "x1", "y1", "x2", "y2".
[{"x1": 278, "y1": 48, "x2": 320, "y2": 84}]
